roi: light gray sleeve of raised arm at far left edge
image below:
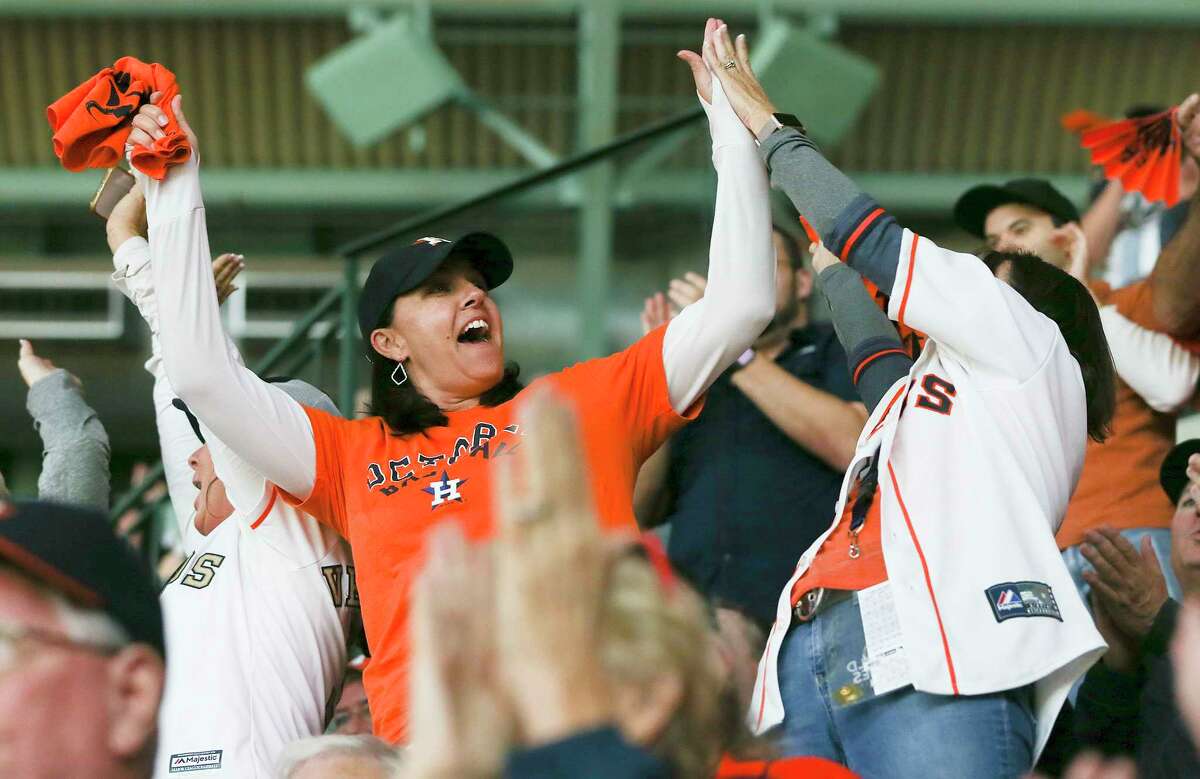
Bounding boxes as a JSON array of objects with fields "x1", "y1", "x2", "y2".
[{"x1": 25, "y1": 370, "x2": 109, "y2": 511}]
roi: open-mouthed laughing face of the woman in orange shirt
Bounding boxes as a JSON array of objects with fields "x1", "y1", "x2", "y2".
[{"x1": 372, "y1": 257, "x2": 504, "y2": 408}]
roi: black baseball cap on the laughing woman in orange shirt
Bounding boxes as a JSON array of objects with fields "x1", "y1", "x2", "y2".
[{"x1": 359, "y1": 233, "x2": 512, "y2": 338}]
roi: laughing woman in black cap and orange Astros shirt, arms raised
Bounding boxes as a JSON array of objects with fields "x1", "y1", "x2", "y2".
[{"x1": 128, "y1": 44, "x2": 775, "y2": 742}]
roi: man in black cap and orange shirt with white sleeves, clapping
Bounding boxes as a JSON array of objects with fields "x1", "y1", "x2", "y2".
[{"x1": 954, "y1": 179, "x2": 1200, "y2": 607}]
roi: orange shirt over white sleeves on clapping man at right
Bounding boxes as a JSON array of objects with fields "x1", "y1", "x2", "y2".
[{"x1": 1056, "y1": 280, "x2": 1200, "y2": 549}]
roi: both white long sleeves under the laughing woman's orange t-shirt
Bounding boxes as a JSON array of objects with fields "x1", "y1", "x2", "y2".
[{"x1": 136, "y1": 79, "x2": 775, "y2": 506}]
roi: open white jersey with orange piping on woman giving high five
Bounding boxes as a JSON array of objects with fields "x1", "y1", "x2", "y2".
[{"x1": 750, "y1": 230, "x2": 1105, "y2": 753}]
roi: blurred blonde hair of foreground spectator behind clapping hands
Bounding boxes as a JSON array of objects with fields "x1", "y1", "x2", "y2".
[{"x1": 600, "y1": 555, "x2": 728, "y2": 779}]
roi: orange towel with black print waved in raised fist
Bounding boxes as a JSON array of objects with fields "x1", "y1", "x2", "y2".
[{"x1": 46, "y1": 56, "x2": 192, "y2": 180}]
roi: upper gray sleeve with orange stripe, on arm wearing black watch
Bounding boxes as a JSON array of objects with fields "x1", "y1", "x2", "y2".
[{"x1": 758, "y1": 127, "x2": 904, "y2": 292}]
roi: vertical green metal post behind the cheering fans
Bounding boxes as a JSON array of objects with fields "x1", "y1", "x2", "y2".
[{"x1": 576, "y1": 0, "x2": 620, "y2": 360}]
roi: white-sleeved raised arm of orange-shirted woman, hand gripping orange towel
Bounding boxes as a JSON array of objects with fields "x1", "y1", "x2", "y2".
[{"x1": 130, "y1": 96, "x2": 316, "y2": 498}]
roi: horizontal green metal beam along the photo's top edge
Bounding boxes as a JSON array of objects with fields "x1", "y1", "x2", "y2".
[{"x1": 9, "y1": 0, "x2": 1200, "y2": 25}]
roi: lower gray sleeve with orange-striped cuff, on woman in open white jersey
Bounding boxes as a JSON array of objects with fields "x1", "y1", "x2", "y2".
[{"x1": 817, "y1": 263, "x2": 912, "y2": 412}]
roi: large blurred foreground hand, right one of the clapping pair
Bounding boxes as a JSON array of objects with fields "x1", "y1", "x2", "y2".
[{"x1": 494, "y1": 393, "x2": 613, "y2": 744}]
